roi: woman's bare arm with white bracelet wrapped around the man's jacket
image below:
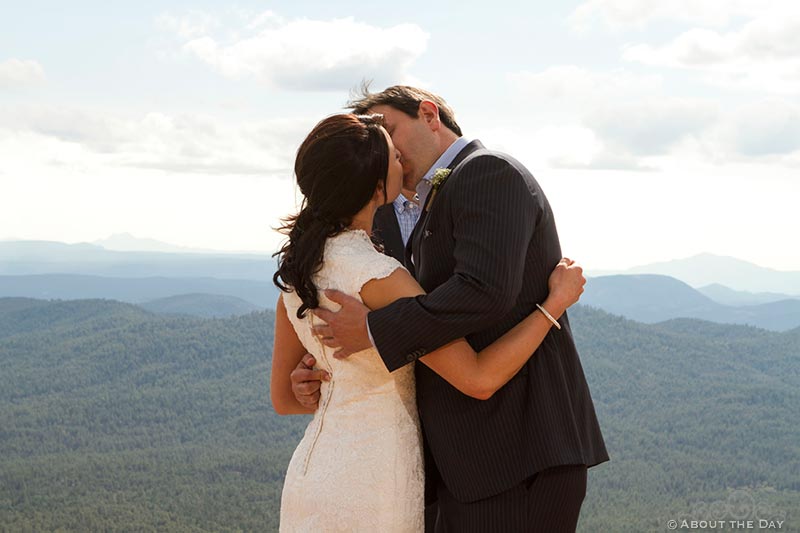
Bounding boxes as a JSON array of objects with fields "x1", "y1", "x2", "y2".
[{"x1": 361, "y1": 263, "x2": 585, "y2": 400}]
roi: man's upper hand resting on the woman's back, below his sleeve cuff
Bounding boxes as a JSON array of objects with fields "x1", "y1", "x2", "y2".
[{"x1": 314, "y1": 290, "x2": 372, "y2": 359}]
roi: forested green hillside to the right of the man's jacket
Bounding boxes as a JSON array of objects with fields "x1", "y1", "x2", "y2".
[{"x1": 570, "y1": 307, "x2": 800, "y2": 532}]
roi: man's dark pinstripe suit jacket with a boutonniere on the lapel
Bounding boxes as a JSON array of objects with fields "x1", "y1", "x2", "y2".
[{"x1": 369, "y1": 141, "x2": 608, "y2": 502}]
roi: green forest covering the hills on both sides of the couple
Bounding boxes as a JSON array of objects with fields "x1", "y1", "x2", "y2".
[{"x1": 0, "y1": 298, "x2": 800, "y2": 533}]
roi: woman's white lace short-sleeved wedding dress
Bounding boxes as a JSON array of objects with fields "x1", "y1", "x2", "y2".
[{"x1": 280, "y1": 230, "x2": 424, "y2": 533}]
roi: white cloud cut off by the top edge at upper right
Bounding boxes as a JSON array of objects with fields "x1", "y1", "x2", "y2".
[{"x1": 569, "y1": 0, "x2": 780, "y2": 31}]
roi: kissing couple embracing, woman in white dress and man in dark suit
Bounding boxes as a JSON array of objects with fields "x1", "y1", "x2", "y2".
[{"x1": 270, "y1": 86, "x2": 608, "y2": 533}]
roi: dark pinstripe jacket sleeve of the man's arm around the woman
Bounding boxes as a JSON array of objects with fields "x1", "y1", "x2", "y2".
[{"x1": 368, "y1": 154, "x2": 541, "y2": 371}]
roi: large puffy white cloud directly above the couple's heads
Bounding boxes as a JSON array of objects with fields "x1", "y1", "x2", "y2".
[{"x1": 162, "y1": 12, "x2": 429, "y2": 90}]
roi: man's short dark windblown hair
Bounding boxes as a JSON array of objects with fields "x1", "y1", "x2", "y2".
[{"x1": 345, "y1": 83, "x2": 463, "y2": 137}]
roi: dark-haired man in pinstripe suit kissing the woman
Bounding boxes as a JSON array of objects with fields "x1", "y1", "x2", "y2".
[{"x1": 292, "y1": 86, "x2": 608, "y2": 533}]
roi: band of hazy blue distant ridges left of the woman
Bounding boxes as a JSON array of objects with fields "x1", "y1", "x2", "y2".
[{"x1": 0, "y1": 240, "x2": 278, "y2": 308}]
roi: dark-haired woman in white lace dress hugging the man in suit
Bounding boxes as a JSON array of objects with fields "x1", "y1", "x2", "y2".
[{"x1": 270, "y1": 115, "x2": 585, "y2": 532}]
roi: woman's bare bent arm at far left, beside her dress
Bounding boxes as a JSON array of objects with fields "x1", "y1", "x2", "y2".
[{"x1": 270, "y1": 294, "x2": 322, "y2": 415}]
